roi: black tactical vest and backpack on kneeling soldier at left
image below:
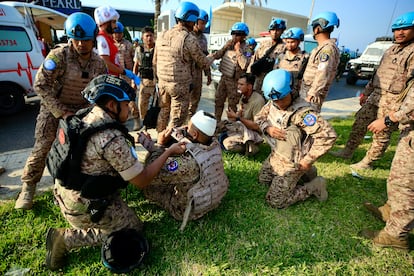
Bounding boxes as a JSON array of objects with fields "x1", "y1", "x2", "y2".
[{"x1": 46, "y1": 107, "x2": 134, "y2": 199}]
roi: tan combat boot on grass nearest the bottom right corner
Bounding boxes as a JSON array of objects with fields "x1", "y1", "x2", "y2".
[{"x1": 360, "y1": 229, "x2": 410, "y2": 250}]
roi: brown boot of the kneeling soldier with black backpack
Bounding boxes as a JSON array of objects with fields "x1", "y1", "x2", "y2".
[{"x1": 46, "y1": 228, "x2": 68, "y2": 270}]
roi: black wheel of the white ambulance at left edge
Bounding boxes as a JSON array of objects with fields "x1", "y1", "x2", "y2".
[{"x1": 0, "y1": 83, "x2": 25, "y2": 115}]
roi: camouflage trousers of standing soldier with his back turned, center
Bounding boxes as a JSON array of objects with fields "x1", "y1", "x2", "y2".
[{"x1": 157, "y1": 81, "x2": 190, "y2": 132}]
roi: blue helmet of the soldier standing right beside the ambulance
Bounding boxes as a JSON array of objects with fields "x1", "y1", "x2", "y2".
[{"x1": 65, "y1": 12, "x2": 98, "y2": 40}]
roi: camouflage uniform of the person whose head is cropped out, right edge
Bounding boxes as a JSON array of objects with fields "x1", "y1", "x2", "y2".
[{"x1": 384, "y1": 81, "x2": 414, "y2": 238}]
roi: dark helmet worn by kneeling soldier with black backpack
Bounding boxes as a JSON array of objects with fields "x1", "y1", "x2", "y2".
[{"x1": 81, "y1": 75, "x2": 135, "y2": 104}]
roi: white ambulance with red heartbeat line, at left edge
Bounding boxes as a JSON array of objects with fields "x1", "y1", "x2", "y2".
[{"x1": 0, "y1": 2, "x2": 67, "y2": 115}]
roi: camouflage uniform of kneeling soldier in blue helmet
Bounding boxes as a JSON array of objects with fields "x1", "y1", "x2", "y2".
[{"x1": 255, "y1": 98, "x2": 336, "y2": 208}]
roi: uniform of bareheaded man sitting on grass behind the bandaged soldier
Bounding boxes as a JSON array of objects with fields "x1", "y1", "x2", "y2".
[{"x1": 223, "y1": 91, "x2": 265, "y2": 152}]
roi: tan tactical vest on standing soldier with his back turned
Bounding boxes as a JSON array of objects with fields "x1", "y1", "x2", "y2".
[{"x1": 156, "y1": 27, "x2": 192, "y2": 83}]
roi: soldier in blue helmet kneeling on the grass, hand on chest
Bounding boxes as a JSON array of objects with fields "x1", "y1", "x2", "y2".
[{"x1": 255, "y1": 69, "x2": 336, "y2": 208}]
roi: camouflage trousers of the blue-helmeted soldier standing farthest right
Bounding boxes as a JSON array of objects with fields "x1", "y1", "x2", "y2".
[{"x1": 345, "y1": 103, "x2": 397, "y2": 161}]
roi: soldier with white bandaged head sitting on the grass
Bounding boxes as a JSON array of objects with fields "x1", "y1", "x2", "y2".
[{"x1": 138, "y1": 110, "x2": 229, "y2": 231}]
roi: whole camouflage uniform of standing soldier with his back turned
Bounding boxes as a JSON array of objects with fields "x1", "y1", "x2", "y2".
[{"x1": 154, "y1": 24, "x2": 210, "y2": 132}]
